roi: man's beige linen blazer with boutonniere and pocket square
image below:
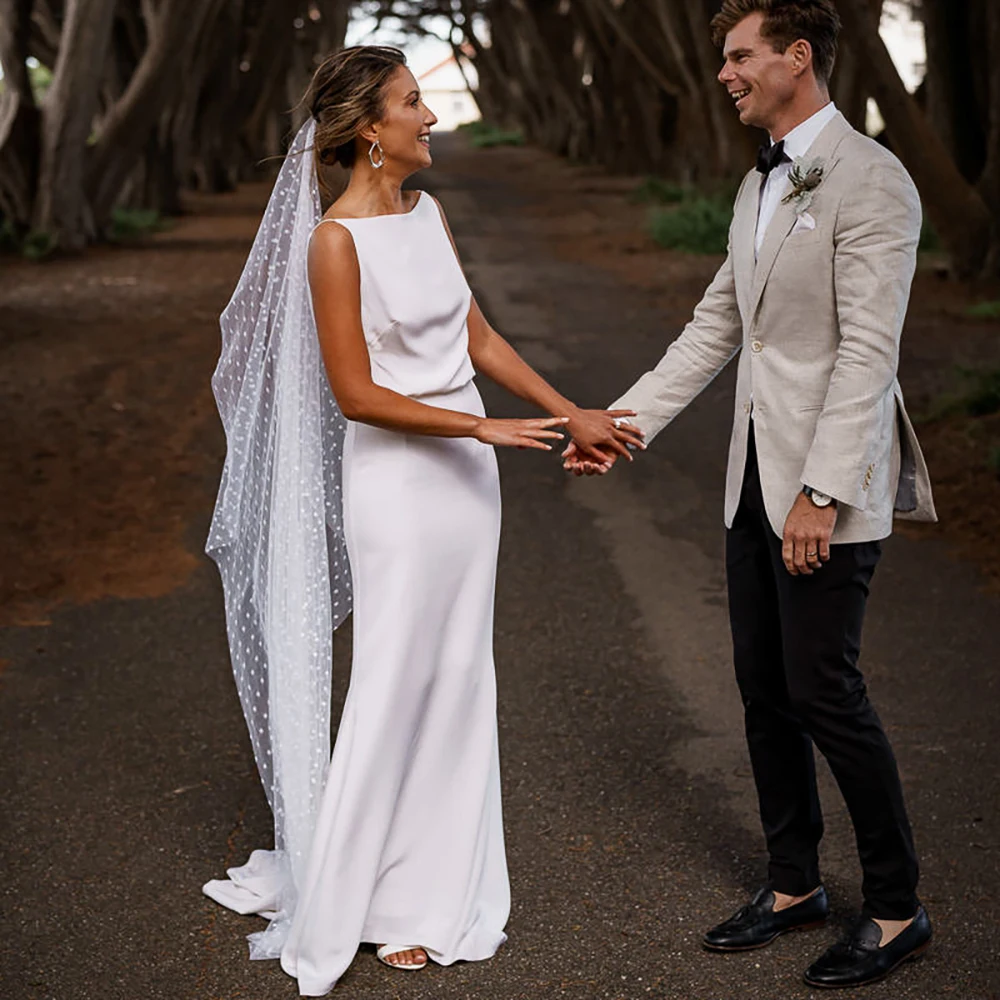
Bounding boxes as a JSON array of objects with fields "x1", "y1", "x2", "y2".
[{"x1": 612, "y1": 114, "x2": 936, "y2": 543}]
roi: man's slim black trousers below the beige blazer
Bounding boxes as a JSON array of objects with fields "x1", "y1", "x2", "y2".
[{"x1": 726, "y1": 423, "x2": 918, "y2": 920}]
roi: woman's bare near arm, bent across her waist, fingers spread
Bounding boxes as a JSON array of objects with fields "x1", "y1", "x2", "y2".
[{"x1": 309, "y1": 225, "x2": 565, "y2": 450}]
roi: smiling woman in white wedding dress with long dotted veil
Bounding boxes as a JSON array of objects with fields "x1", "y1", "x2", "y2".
[{"x1": 205, "y1": 46, "x2": 642, "y2": 996}]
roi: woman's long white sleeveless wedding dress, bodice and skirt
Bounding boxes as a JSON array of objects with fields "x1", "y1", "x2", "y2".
[{"x1": 281, "y1": 194, "x2": 510, "y2": 996}]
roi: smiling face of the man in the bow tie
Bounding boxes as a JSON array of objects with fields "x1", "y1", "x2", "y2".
[{"x1": 719, "y1": 13, "x2": 800, "y2": 131}]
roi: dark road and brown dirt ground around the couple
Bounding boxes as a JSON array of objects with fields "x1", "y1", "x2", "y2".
[{"x1": 0, "y1": 139, "x2": 1000, "y2": 1000}]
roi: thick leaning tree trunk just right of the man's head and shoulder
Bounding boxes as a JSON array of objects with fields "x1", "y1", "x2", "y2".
[{"x1": 838, "y1": 0, "x2": 991, "y2": 275}]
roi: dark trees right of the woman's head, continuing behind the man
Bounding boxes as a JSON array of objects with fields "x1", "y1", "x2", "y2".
[{"x1": 361, "y1": 0, "x2": 1000, "y2": 276}]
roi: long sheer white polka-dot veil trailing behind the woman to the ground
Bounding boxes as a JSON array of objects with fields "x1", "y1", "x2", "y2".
[{"x1": 204, "y1": 118, "x2": 351, "y2": 958}]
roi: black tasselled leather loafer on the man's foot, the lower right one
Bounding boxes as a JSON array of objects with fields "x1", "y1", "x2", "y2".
[{"x1": 805, "y1": 907, "x2": 933, "y2": 989}]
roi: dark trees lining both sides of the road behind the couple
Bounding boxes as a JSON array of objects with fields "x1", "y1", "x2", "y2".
[{"x1": 0, "y1": 0, "x2": 1000, "y2": 276}]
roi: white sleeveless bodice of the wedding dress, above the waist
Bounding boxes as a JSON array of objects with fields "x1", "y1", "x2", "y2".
[{"x1": 322, "y1": 192, "x2": 475, "y2": 397}]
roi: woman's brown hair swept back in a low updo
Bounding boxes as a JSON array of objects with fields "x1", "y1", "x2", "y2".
[{"x1": 305, "y1": 45, "x2": 406, "y2": 169}]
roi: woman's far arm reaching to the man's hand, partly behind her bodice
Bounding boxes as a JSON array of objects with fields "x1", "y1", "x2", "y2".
[{"x1": 426, "y1": 193, "x2": 643, "y2": 462}]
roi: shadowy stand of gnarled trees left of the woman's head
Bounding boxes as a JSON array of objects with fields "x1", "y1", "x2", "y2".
[{"x1": 0, "y1": 0, "x2": 351, "y2": 249}]
